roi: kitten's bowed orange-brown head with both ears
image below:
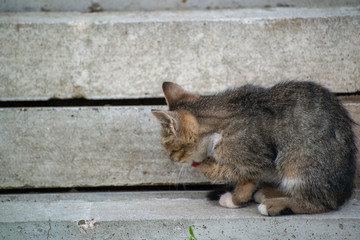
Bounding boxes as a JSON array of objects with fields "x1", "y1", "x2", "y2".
[{"x1": 151, "y1": 82, "x2": 200, "y2": 166}]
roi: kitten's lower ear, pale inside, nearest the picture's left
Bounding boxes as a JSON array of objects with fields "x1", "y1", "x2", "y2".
[{"x1": 151, "y1": 110, "x2": 181, "y2": 136}]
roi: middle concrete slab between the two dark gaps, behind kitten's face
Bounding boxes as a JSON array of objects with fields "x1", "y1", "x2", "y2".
[{"x1": 0, "y1": 100, "x2": 360, "y2": 189}]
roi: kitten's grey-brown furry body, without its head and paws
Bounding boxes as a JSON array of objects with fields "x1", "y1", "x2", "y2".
[{"x1": 158, "y1": 81, "x2": 357, "y2": 209}]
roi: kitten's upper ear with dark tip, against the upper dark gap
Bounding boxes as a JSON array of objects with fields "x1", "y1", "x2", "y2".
[{"x1": 162, "y1": 82, "x2": 200, "y2": 106}]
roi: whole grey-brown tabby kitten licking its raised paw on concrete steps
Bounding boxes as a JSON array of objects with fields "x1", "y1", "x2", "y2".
[{"x1": 152, "y1": 82, "x2": 357, "y2": 216}]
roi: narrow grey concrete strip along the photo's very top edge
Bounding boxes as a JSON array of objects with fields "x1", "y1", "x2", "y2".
[{"x1": 0, "y1": 0, "x2": 359, "y2": 12}]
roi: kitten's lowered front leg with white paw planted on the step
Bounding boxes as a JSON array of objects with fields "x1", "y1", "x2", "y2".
[{"x1": 219, "y1": 181, "x2": 256, "y2": 208}]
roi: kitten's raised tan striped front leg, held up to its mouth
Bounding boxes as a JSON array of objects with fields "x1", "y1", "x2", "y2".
[{"x1": 197, "y1": 157, "x2": 239, "y2": 181}]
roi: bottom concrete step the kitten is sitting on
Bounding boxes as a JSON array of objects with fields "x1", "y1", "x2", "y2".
[{"x1": 0, "y1": 192, "x2": 360, "y2": 240}]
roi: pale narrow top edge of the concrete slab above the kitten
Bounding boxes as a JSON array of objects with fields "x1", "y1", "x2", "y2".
[{"x1": 0, "y1": 5, "x2": 360, "y2": 25}]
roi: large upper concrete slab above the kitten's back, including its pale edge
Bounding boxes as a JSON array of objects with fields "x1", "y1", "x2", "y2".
[{"x1": 0, "y1": 7, "x2": 360, "y2": 101}]
